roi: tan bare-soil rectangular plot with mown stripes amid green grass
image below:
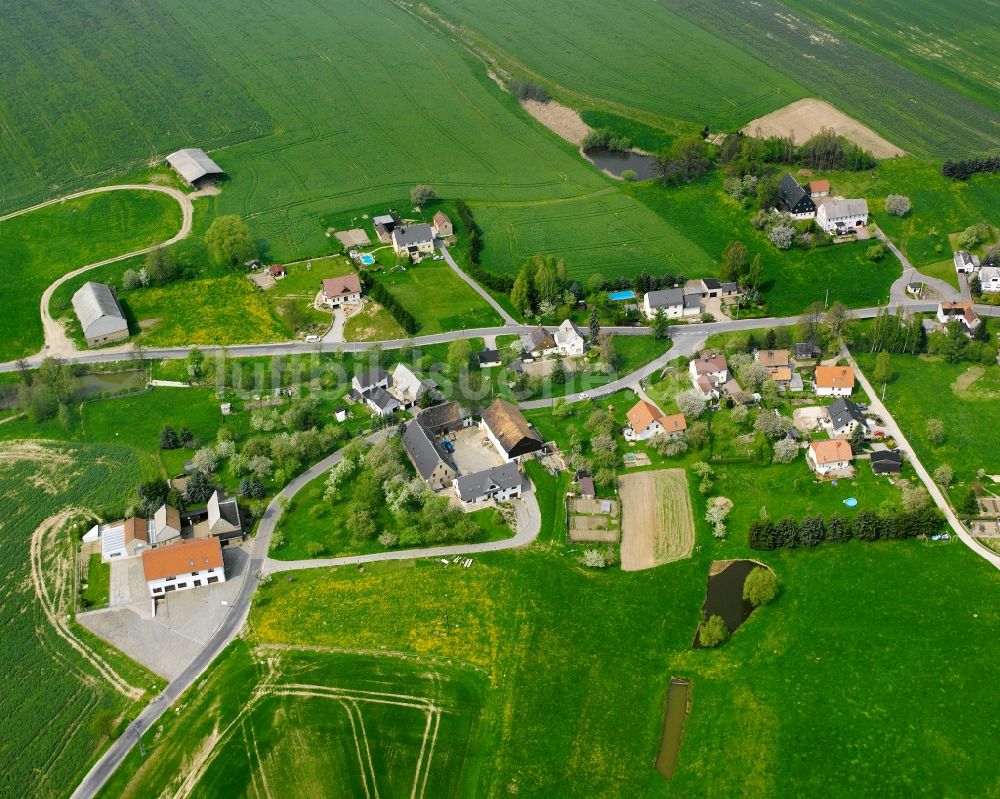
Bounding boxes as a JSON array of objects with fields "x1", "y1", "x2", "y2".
[{"x1": 618, "y1": 469, "x2": 694, "y2": 571}]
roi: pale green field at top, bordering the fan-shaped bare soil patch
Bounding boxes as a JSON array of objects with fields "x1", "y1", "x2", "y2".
[{"x1": 420, "y1": 0, "x2": 805, "y2": 128}]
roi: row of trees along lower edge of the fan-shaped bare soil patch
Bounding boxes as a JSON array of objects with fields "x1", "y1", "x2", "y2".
[{"x1": 719, "y1": 128, "x2": 877, "y2": 175}]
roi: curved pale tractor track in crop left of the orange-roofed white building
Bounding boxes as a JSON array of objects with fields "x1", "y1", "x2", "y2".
[{"x1": 31, "y1": 508, "x2": 144, "y2": 701}]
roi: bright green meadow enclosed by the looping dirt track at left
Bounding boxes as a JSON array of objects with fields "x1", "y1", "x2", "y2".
[{"x1": 0, "y1": 191, "x2": 181, "y2": 361}]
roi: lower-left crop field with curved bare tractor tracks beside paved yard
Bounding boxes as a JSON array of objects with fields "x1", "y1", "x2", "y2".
[{"x1": 0, "y1": 444, "x2": 161, "y2": 797}]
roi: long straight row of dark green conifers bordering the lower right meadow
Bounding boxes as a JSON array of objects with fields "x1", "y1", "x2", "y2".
[{"x1": 747, "y1": 505, "x2": 944, "y2": 550}]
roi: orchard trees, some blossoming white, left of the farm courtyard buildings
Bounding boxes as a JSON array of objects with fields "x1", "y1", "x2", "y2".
[{"x1": 324, "y1": 436, "x2": 481, "y2": 548}]
